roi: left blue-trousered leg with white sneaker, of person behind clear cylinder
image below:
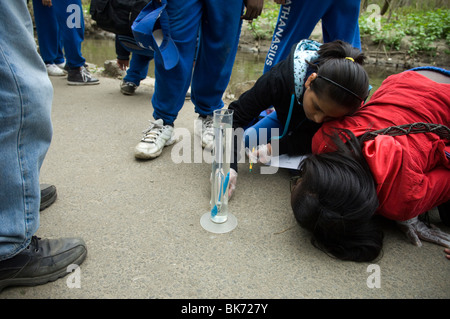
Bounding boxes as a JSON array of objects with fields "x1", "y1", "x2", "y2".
[{"x1": 134, "y1": 0, "x2": 203, "y2": 159}]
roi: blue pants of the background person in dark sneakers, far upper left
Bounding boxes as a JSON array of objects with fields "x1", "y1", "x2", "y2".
[{"x1": 33, "y1": 0, "x2": 86, "y2": 68}]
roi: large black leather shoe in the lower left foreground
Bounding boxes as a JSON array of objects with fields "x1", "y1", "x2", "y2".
[{"x1": 0, "y1": 236, "x2": 87, "y2": 292}]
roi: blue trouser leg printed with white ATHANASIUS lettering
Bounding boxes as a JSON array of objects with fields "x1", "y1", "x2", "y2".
[{"x1": 264, "y1": 0, "x2": 333, "y2": 73}]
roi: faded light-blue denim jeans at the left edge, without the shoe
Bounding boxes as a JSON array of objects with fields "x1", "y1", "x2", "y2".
[{"x1": 0, "y1": 0, "x2": 53, "y2": 260}]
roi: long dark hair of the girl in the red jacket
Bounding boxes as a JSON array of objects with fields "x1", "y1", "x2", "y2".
[{"x1": 291, "y1": 130, "x2": 383, "y2": 262}]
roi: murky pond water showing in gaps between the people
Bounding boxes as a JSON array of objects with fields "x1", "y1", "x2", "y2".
[{"x1": 82, "y1": 38, "x2": 403, "y2": 97}]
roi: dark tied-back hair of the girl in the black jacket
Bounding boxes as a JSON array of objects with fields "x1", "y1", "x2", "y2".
[{"x1": 310, "y1": 40, "x2": 369, "y2": 112}]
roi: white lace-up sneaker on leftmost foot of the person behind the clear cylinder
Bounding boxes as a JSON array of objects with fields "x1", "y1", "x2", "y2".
[{"x1": 134, "y1": 119, "x2": 176, "y2": 159}]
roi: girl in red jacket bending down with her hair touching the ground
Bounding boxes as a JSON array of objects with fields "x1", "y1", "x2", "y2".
[{"x1": 291, "y1": 70, "x2": 450, "y2": 261}]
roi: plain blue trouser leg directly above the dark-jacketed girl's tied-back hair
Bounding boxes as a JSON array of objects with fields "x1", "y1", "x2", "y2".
[{"x1": 322, "y1": 0, "x2": 361, "y2": 50}]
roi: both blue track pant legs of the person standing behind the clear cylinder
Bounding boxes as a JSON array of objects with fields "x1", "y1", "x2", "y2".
[{"x1": 152, "y1": 0, "x2": 244, "y2": 124}]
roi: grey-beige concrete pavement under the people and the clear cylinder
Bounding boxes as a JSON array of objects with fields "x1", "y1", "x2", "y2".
[{"x1": 0, "y1": 72, "x2": 450, "y2": 299}]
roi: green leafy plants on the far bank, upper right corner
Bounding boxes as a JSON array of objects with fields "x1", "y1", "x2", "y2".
[{"x1": 359, "y1": 8, "x2": 450, "y2": 54}]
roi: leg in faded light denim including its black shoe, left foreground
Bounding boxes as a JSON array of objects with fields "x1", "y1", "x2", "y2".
[{"x1": 0, "y1": 0, "x2": 87, "y2": 292}]
